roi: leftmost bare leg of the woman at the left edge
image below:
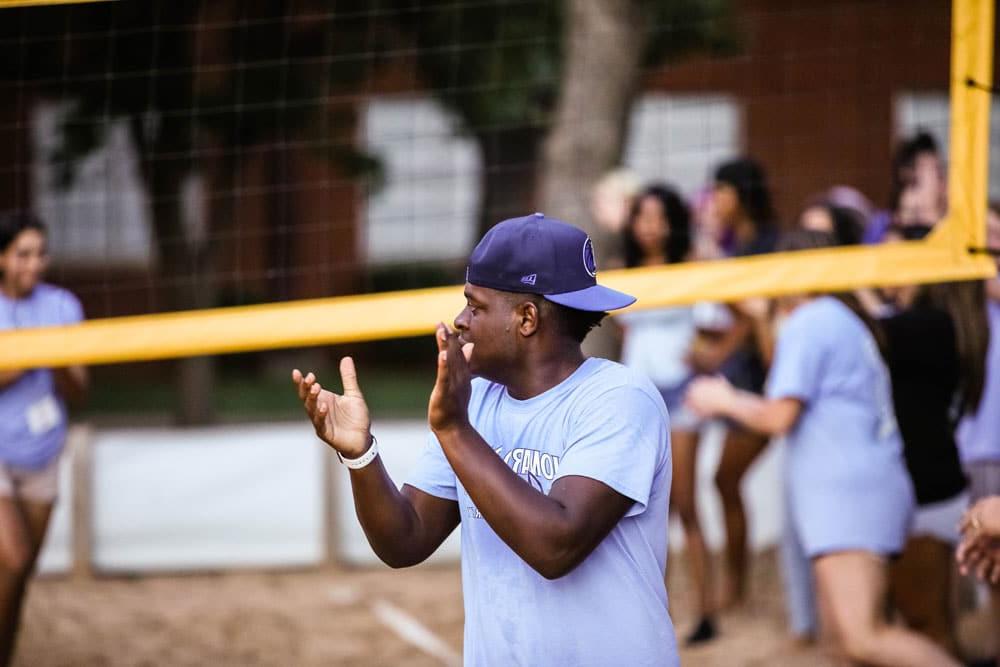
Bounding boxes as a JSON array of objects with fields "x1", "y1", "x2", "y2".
[{"x1": 0, "y1": 497, "x2": 32, "y2": 666}]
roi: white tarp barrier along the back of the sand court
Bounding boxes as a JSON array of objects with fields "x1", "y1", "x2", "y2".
[{"x1": 40, "y1": 420, "x2": 782, "y2": 572}]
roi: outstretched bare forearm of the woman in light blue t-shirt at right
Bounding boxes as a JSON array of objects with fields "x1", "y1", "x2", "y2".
[{"x1": 685, "y1": 377, "x2": 802, "y2": 436}]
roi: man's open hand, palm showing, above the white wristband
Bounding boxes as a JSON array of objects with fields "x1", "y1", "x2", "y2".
[{"x1": 292, "y1": 357, "x2": 371, "y2": 459}]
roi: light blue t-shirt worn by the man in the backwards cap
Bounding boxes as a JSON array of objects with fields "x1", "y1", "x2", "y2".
[{"x1": 408, "y1": 359, "x2": 678, "y2": 667}]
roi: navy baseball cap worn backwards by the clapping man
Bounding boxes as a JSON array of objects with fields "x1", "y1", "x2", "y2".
[{"x1": 465, "y1": 213, "x2": 635, "y2": 312}]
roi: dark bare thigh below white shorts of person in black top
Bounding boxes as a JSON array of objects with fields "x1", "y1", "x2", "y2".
[{"x1": 889, "y1": 536, "x2": 958, "y2": 655}]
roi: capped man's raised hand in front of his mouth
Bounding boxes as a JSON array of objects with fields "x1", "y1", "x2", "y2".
[{"x1": 427, "y1": 324, "x2": 473, "y2": 432}]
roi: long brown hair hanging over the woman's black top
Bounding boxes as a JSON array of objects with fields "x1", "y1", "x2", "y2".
[{"x1": 914, "y1": 280, "x2": 990, "y2": 414}]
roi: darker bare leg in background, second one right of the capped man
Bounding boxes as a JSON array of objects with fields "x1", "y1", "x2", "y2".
[{"x1": 715, "y1": 429, "x2": 768, "y2": 608}]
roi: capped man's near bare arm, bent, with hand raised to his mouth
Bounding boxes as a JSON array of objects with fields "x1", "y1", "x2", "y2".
[{"x1": 428, "y1": 325, "x2": 635, "y2": 579}]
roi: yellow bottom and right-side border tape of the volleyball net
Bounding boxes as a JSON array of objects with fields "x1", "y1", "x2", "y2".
[{"x1": 0, "y1": 0, "x2": 996, "y2": 368}]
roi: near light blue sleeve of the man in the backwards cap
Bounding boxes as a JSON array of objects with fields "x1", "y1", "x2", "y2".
[{"x1": 556, "y1": 386, "x2": 669, "y2": 516}]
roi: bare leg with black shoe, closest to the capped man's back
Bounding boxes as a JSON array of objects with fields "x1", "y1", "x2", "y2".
[{"x1": 670, "y1": 431, "x2": 715, "y2": 641}]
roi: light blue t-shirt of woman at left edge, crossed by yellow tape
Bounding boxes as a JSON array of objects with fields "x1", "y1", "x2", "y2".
[{"x1": 0, "y1": 283, "x2": 83, "y2": 470}]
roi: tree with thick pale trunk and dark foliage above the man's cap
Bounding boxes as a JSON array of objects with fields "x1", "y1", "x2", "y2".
[{"x1": 383, "y1": 0, "x2": 734, "y2": 236}]
